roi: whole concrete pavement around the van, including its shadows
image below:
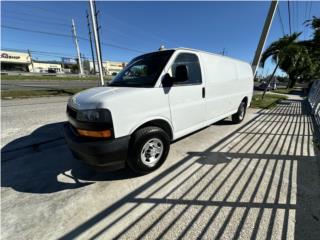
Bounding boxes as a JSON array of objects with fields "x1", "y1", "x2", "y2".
[{"x1": 1, "y1": 94, "x2": 320, "y2": 239}]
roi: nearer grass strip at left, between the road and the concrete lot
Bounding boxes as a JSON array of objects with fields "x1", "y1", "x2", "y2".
[{"x1": 1, "y1": 88, "x2": 85, "y2": 99}]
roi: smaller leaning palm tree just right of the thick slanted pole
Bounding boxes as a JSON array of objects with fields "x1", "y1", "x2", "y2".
[{"x1": 260, "y1": 33, "x2": 301, "y2": 98}]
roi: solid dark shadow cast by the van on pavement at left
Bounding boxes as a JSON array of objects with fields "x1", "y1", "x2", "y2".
[{"x1": 1, "y1": 122, "x2": 134, "y2": 193}]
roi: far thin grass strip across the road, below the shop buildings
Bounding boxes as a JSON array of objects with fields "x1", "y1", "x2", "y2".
[{"x1": 1, "y1": 75, "x2": 112, "y2": 81}]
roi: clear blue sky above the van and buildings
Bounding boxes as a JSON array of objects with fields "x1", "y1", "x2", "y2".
[{"x1": 1, "y1": 1, "x2": 320, "y2": 74}]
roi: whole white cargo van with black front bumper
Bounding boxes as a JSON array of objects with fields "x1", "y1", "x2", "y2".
[{"x1": 65, "y1": 48, "x2": 253, "y2": 174}]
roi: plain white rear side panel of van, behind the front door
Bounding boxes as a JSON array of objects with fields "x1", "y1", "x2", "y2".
[{"x1": 201, "y1": 53, "x2": 253, "y2": 123}]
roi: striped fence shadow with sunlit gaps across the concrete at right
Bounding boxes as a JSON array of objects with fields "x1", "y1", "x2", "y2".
[{"x1": 56, "y1": 99, "x2": 320, "y2": 239}]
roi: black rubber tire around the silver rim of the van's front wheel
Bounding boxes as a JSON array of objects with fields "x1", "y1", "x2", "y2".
[{"x1": 127, "y1": 127, "x2": 170, "y2": 174}]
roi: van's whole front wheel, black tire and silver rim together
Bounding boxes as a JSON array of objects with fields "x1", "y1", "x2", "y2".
[{"x1": 128, "y1": 127, "x2": 170, "y2": 174}]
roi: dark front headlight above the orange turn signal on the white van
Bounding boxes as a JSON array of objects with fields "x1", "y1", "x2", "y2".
[{"x1": 77, "y1": 109, "x2": 112, "y2": 122}]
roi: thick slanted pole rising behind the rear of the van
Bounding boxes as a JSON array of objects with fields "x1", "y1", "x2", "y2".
[{"x1": 251, "y1": 0, "x2": 278, "y2": 76}]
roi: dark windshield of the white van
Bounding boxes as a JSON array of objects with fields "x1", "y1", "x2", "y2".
[{"x1": 108, "y1": 50, "x2": 174, "y2": 87}]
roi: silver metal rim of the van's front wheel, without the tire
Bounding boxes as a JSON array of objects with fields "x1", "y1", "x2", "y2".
[{"x1": 141, "y1": 138, "x2": 163, "y2": 167}]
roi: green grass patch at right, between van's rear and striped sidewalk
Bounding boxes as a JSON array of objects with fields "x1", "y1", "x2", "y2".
[{"x1": 251, "y1": 93, "x2": 288, "y2": 109}]
